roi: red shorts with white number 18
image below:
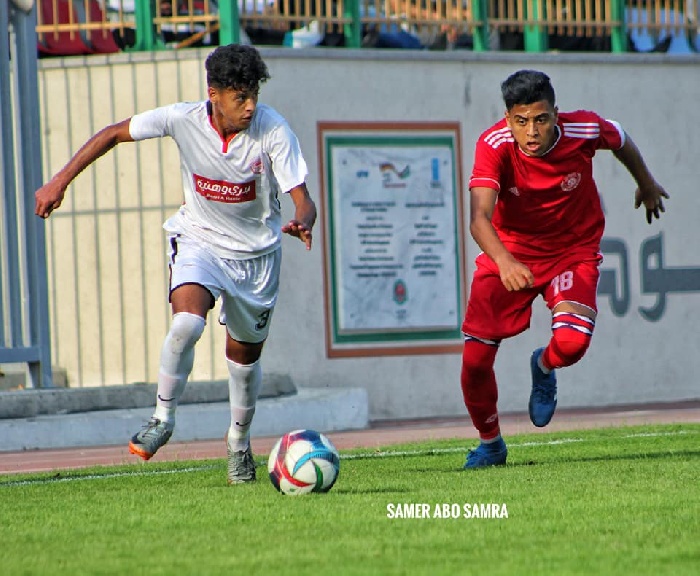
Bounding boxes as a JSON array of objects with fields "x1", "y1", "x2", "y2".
[{"x1": 462, "y1": 254, "x2": 603, "y2": 341}]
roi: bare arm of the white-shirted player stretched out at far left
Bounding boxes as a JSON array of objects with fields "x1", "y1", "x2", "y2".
[{"x1": 34, "y1": 118, "x2": 133, "y2": 218}]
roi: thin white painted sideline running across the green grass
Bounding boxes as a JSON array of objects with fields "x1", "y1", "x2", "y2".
[{"x1": 0, "y1": 430, "x2": 700, "y2": 487}]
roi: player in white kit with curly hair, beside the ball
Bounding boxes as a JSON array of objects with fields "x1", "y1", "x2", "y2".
[{"x1": 35, "y1": 45, "x2": 316, "y2": 484}]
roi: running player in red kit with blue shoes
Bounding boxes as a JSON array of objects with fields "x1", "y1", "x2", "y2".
[{"x1": 461, "y1": 70, "x2": 668, "y2": 469}]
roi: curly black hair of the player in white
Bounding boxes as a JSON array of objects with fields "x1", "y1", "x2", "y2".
[{"x1": 204, "y1": 44, "x2": 270, "y2": 92}]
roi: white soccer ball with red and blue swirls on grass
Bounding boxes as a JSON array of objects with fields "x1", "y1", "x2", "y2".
[{"x1": 267, "y1": 430, "x2": 340, "y2": 496}]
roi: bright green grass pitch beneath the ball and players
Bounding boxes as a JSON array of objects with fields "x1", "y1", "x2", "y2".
[{"x1": 0, "y1": 425, "x2": 700, "y2": 576}]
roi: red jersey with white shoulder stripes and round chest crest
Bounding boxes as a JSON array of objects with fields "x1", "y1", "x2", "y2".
[{"x1": 469, "y1": 110, "x2": 625, "y2": 261}]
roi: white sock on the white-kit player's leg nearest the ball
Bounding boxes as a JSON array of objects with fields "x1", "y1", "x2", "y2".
[{"x1": 226, "y1": 358, "x2": 262, "y2": 452}]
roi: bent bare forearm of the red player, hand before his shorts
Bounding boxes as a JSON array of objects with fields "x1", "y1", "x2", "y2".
[{"x1": 469, "y1": 186, "x2": 535, "y2": 292}]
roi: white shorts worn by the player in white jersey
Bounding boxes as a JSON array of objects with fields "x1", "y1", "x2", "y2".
[{"x1": 168, "y1": 234, "x2": 282, "y2": 344}]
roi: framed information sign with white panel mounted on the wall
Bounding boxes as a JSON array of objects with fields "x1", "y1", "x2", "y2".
[{"x1": 318, "y1": 122, "x2": 465, "y2": 357}]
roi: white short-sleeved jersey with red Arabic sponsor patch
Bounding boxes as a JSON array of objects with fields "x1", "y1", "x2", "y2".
[{"x1": 129, "y1": 100, "x2": 307, "y2": 259}]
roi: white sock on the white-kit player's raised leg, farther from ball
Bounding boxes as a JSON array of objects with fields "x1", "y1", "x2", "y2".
[{"x1": 153, "y1": 312, "x2": 206, "y2": 428}]
